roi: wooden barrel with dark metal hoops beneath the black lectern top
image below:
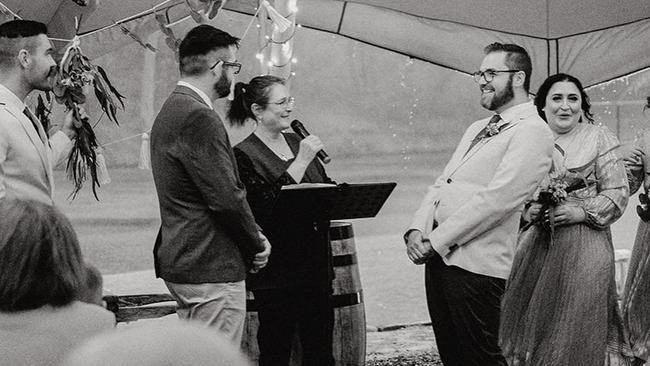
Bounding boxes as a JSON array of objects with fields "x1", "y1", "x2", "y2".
[{"x1": 242, "y1": 222, "x2": 366, "y2": 366}]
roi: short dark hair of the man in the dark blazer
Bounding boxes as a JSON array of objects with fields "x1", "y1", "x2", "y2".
[{"x1": 178, "y1": 24, "x2": 239, "y2": 76}]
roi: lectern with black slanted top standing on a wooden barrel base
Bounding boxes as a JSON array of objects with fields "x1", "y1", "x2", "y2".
[{"x1": 242, "y1": 183, "x2": 397, "y2": 366}]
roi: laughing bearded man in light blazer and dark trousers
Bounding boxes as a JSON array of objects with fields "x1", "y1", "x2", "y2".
[{"x1": 404, "y1": 43, "x2": 553, "y2": 366}]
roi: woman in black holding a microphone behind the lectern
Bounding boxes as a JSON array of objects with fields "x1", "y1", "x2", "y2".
[{"x1": 228, "y1": 75, "x2": 334, "y2": 366}]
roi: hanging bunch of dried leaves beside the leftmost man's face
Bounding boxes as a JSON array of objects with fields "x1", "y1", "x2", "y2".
[{"x1": 53, "y1": 38, "x2": 124, "y2": 200}]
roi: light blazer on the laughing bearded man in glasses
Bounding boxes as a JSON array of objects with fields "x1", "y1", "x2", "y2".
[{"x1": 409, "y1": 102, "x2": 553, "y2": 279}]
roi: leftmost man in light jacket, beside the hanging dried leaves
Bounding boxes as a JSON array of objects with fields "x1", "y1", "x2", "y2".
[{"x1": 0, "y1": 20, "x2": 76, "y2": 205}]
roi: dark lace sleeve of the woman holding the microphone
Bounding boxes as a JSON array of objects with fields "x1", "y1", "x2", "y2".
[{"x1": 234, "y1": 149, "x2": 295, "y2": 224}]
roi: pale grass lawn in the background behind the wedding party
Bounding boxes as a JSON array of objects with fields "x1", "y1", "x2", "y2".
[{"x1": 55, "y1": 154, "x2": 638, "y2": 326}]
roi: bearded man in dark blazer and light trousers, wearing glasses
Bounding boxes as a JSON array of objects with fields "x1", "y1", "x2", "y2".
[{"x1": 151, "y1": 25, "x2": 270, "y2": 345}]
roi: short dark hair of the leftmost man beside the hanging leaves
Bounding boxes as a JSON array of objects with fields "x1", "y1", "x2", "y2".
[{"x1": 0, "y1": 19, "x2": 47, "y2": 67}]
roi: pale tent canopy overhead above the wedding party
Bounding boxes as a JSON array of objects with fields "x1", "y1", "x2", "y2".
[{"x1": 3, "y1": 0, "x2": 650, "y2": 90}]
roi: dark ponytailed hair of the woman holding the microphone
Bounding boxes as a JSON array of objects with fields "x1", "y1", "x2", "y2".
[{"x1": 228, "y1": 75, "x2": 285, "y2": 126}]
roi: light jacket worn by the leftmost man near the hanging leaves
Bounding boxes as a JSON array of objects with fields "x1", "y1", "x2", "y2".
[{"x1": 0, "y1": 85, "x2": 72, "y2": 205}]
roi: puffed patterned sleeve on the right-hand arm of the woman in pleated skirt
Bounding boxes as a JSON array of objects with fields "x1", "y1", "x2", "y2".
[{"x1": 583, "y1": 128, "x2": 629, "y2": 229}]
